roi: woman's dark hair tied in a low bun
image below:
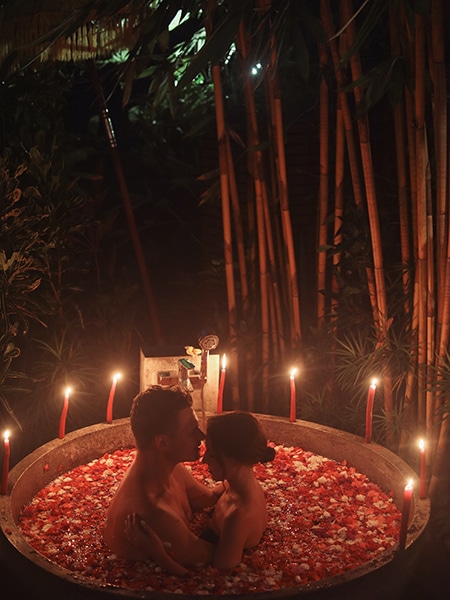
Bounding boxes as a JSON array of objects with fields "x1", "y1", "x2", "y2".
[{"x1": 206, "y1": 410, "x2": 275, "y2": 465}]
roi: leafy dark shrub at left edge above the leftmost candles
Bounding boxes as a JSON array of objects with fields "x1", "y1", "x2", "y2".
[{"x1": 0, "y1": 122, "x2": 96, "y2": 424}]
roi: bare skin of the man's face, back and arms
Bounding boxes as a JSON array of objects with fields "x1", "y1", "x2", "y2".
[{"x1": 103, "y1": 392, "x2": 217, "y2": 566}]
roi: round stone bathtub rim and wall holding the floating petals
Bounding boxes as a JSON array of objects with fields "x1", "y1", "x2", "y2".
[{"x1": 0, "y1": 415, "x2": 430, "y2": 600}]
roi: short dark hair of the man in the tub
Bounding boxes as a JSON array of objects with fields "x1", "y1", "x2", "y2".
[{"x1": 130, "y1": 385, "x2": 192, "y2": 450}]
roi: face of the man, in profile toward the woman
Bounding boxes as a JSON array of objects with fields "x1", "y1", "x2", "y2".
[{"x1": 168, "y1": 407, "x2": 205, "y2": 463}]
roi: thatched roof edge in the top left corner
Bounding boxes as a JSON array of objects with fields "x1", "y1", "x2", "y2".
[{"x1": 0, "y1": 0, "x2": 147, "y2": 69}]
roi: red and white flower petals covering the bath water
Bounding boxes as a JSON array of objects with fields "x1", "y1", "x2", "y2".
[{"x1": 19, "y1": 446, "x2": 400, "y2": 594}]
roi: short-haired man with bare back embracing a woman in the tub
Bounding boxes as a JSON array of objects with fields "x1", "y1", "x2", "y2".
[{"x1": 103, "y1": 386, "x2": 224, "y2": 574}]
